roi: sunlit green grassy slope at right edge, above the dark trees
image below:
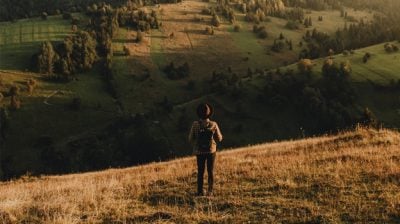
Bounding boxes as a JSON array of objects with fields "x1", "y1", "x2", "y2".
[{"x1": 282, "y1": 41, "x2": 400, "y2": 127}]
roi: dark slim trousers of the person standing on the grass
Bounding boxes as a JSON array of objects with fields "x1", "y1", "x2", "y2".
[{"x1": 196, "y1": 153, "x2": 217, "y2": 194}]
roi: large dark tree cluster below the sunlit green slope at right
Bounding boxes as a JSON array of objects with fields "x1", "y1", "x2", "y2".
[{"x1": 260, "y1": 59, "x2": 361, "y2": 133}]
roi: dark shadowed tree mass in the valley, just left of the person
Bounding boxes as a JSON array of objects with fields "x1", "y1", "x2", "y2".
[{"x1": 31, "y1": 114, "x2": 172, "y2": 176}]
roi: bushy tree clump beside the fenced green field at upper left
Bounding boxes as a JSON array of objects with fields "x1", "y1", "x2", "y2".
[{"x1": 34, "y1": 31, "x2": 97, "y2": 79}]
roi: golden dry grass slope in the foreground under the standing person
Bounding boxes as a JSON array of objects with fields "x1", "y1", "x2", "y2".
[{"x1": 0, "y1": 129, "x2": 400, "y2": 223}]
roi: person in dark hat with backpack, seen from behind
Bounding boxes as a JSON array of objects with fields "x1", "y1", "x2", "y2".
[{"x1": 189, "y1": 103, "x2": 222, "y2": 196}]
